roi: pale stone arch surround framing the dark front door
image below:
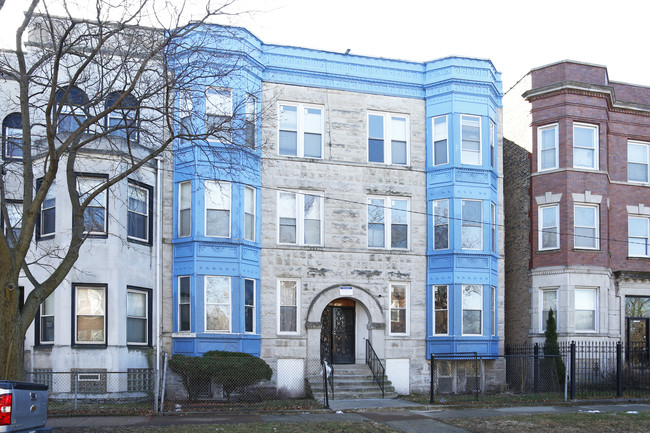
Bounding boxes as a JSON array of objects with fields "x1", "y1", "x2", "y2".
[{"x1": 305, "y1": 285, "x2": 386, "y2": 363}]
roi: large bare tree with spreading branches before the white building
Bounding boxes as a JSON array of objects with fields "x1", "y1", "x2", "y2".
[{"x1": 0, "y1": 0, "x2": 253, "y2": 379}]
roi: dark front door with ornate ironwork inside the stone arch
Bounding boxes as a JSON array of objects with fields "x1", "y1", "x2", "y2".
[{"x1": 321, "y1": 299, "x2": 355, "y2": 364}]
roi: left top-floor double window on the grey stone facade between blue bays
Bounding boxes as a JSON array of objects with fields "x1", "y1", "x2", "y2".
[{"x1": 278, "y1": 103, "x2": 323, "y2": 158}]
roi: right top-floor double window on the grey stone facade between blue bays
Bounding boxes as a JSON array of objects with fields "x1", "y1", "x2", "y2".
[{"x1": 368, "y1": 113, "x2": 409, "y2": 165}]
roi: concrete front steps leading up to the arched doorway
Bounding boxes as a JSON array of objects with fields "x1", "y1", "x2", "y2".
[{"x1": 307, "y1": 364, "x2": 397, "y2": 401}]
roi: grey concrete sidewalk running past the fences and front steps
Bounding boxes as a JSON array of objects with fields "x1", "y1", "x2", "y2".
[{"x1": 47, "y1": 399, "x2": 650, "y2": 433}]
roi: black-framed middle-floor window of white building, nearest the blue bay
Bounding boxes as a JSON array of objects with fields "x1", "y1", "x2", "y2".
[{"x1": 127, "y1": 180, "x2": 153, "y2": 244}]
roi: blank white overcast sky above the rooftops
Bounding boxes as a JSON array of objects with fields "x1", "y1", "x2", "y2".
[{"x1": 0, "y1": 0, "x2": 650, "y2": 91}]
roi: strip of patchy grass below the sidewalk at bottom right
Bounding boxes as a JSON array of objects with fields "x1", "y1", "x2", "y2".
[{"x1": 442, "y1": 412, "x2": 650, "y2": 433}]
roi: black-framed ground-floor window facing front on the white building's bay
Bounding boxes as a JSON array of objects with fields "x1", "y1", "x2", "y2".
[{"x1": 72, "y1": 285, "x2": 106, "y2": 344}]
